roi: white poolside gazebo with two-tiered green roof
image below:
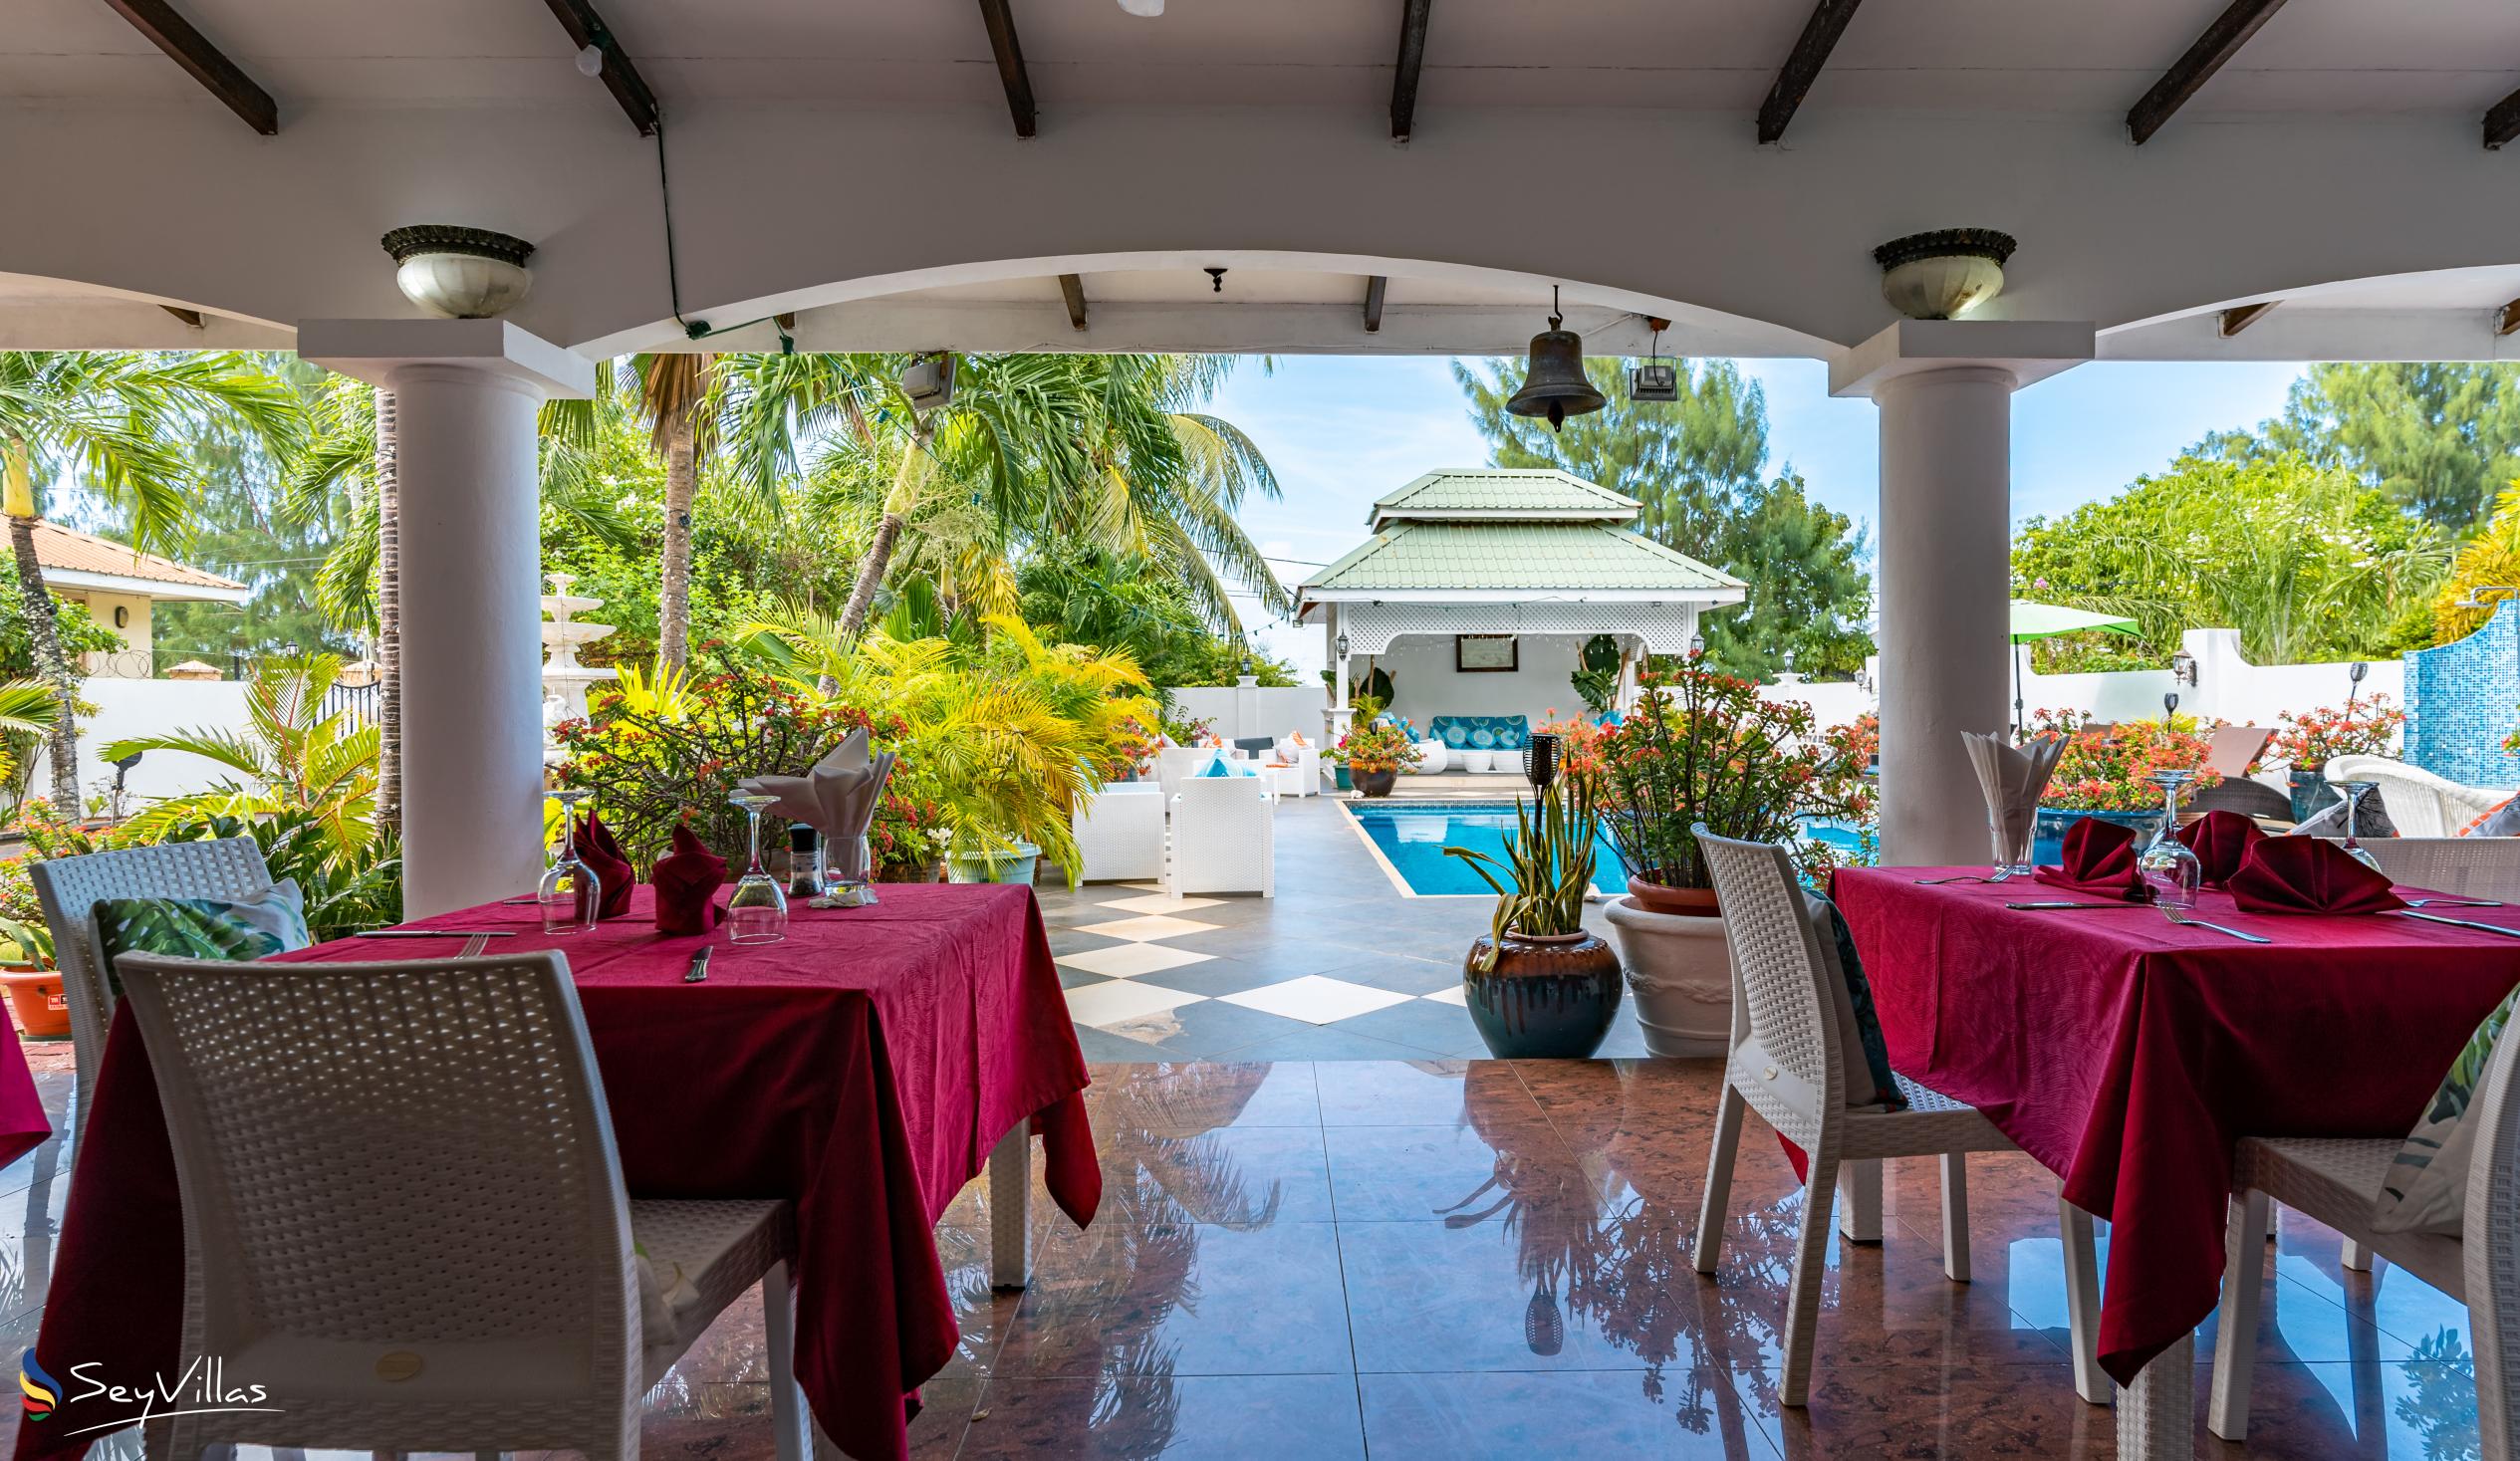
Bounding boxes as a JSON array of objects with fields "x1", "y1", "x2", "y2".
[{"x1": 1295, "y1": 466, "x2": 1744, "y2": 736}]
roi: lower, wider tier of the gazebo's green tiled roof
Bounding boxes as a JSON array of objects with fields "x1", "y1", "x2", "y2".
[{"x1": 1303, "y1": 522, "x2": 1744, "y2": 597}]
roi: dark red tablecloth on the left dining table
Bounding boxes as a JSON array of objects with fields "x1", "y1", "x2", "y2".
[{"x1": 18, "y1": 884, "x2": 1102, "y2": 1461}]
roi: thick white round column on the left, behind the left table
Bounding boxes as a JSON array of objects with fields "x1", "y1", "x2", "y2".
[{"x1": 298, "y1": 320, "x2": 595, "y2": 917}]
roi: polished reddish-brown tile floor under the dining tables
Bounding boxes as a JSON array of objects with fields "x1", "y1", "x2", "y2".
[{"x1": 0, "y1": 1061, "x2": 2474, "y2": 1461}]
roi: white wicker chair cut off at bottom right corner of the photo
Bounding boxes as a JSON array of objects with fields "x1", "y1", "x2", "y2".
[{"x1": 2179, "y1": 992, "x2": 2520, "y2": 1461}]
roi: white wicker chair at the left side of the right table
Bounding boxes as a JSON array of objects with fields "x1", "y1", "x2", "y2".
[{"x1": 1693, "y1": 829, "x2": 2110, "y2": 1405}]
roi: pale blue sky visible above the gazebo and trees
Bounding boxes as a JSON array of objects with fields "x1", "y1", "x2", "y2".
[{"x1": 1209, "y1": 356, "x2": 2301, "y2": 675}]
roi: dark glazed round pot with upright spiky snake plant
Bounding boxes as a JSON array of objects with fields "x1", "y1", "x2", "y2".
[{"x1": 1444, "y1": 779, "x2": 1618, "y2": 1061}]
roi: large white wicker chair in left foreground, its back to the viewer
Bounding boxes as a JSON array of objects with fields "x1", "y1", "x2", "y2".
[{"x1": 116, "y1": 952, "x2": 809, "y2": 1461}]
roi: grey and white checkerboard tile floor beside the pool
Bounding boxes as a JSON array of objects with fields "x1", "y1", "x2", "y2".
[{"x1": 1041, "y1": 799, "x2": 1643, "y2": 1061}]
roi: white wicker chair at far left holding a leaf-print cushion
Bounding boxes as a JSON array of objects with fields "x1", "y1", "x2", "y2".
[{"x1": 28, "y1": 837, "x2": 272, "y2": 1161}]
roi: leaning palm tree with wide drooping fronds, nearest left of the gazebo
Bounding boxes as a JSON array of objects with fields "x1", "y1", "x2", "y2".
[{"x1": 716, "y1": 356, "x2": 1288, "y2": 637}]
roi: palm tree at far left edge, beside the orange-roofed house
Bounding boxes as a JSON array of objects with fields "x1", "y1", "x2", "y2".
[{"x1": 0, "y1": 351, "x2": 305, "y2": 816}]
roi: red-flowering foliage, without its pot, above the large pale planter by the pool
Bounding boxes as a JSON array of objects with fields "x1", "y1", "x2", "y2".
[{"x1": 1595, "y1": 660, "x2": 1863, "y2": 889}]
